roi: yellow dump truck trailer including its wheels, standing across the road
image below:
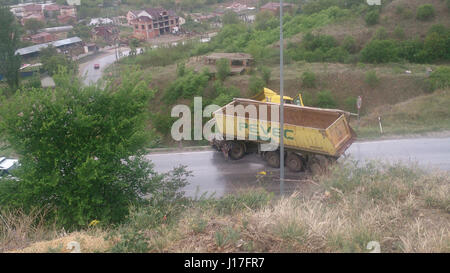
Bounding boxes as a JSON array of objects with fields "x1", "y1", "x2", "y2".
[{"x1": 210, "y1": 99, "x2": 356, "y2": 172}]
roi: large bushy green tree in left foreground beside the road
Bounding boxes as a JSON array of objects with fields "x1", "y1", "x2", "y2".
[{"x1": 0, "y1": 69, "x2": 185, "y2": 229}]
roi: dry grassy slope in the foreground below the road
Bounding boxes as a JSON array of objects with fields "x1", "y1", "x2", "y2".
[{"x1": 4, "y1": 162, "x2": 450, "y2": 253}]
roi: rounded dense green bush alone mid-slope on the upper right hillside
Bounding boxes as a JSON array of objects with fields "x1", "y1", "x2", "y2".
[{"x1": 361, "y1": 40, "x2": 398, "y2": 63}]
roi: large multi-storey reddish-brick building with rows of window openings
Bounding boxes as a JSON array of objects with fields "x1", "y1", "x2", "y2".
[{"x1": 131, "y1": 8, "x2": 180, "y2": 40}]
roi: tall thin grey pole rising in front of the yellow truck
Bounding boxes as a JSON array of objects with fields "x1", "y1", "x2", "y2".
[{"x1": 280, "y1": 0, "x2": 284, "y2": 196}]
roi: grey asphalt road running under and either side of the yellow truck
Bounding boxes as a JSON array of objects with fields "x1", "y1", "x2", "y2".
[{"x1": 147, "y1": 137, "x2": 450, "y2": 197}]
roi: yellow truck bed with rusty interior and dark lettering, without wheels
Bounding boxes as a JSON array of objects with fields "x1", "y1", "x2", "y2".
[{"x1": 214, "y1": 99, "x2": 355, "y2": 157}]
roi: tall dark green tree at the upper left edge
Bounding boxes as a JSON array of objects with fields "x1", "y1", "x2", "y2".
[{"x1": 0, "y1": 6, "x2": 21, "y2": 89}]
